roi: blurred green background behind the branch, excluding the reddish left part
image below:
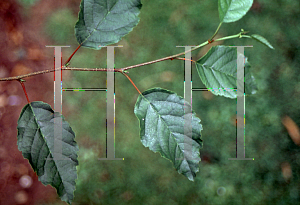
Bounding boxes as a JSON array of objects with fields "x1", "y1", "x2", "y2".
[{"x1": 38, "y1": 0, "x2": 300, "y2": 205}]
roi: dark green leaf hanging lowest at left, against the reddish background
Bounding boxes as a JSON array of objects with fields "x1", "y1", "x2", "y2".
[{"x1": 17, "y1": 102, "x2": 78, "y2": 204}]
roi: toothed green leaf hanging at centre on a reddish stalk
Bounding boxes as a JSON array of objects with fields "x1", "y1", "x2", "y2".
[{"x1": 134, "y1": 88, "x2": 202, "y2": 181}]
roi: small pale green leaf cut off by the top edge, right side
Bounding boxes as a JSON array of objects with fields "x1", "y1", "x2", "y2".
[{"x1": 218, "y1": 0, "x2": 253, "y2": 23}]
